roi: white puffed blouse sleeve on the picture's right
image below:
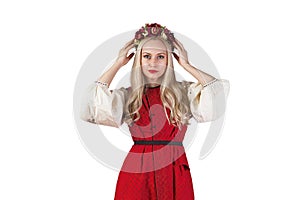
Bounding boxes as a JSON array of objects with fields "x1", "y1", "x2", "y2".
[{"x1": 184, "y1": 79, "x2": 230, "y2": 122}]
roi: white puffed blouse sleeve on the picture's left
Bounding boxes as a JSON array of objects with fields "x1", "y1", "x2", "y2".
[{"x1": 80, "y1": 82, "x2": 128, "y2": 127}]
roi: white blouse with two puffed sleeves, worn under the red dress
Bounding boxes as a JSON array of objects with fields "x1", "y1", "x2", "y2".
[{"x1": 80, "y1": 79, "x2": 230, "y2": 127}]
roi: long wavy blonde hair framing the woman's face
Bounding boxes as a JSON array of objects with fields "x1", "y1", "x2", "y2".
[{"x1": 125, "y1": 37, "x2": 190, "y2": 128}]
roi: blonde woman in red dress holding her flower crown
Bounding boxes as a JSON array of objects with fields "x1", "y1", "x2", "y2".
[{"x1": 81, "y1": 23, "x2": 229, "y2": 200}]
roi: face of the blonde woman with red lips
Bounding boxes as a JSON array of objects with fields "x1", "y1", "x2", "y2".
[{"x1": 141, "y1": 40, "x2": 168, "y2": 83}]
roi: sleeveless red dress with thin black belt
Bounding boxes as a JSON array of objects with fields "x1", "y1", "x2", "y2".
[{"x1": 114, "y1": 86, "x2": 194, "y2": 200}]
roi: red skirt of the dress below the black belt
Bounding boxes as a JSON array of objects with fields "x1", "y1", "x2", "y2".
[{"x1": 114, "y1": 142, "x2": 194, "y2": 200}]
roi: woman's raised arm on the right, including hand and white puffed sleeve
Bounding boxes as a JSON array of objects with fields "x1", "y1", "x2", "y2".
[{"x1": 173, "y1": 39, "x2": 229, "y2": 122}]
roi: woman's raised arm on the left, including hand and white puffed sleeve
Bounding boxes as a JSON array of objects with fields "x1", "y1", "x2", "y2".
[{"x1": 80, "y1": 41, "x2": 134, "y2": 127}]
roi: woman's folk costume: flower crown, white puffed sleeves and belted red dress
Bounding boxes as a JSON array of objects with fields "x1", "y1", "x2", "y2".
[{"x1": 81, "y1": 24, "x2": 229, "y2": 200}]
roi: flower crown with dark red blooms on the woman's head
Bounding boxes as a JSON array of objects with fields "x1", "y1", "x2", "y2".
[{"x1": 134, "y1": 23, "x2": 175, "y2": 51}]
